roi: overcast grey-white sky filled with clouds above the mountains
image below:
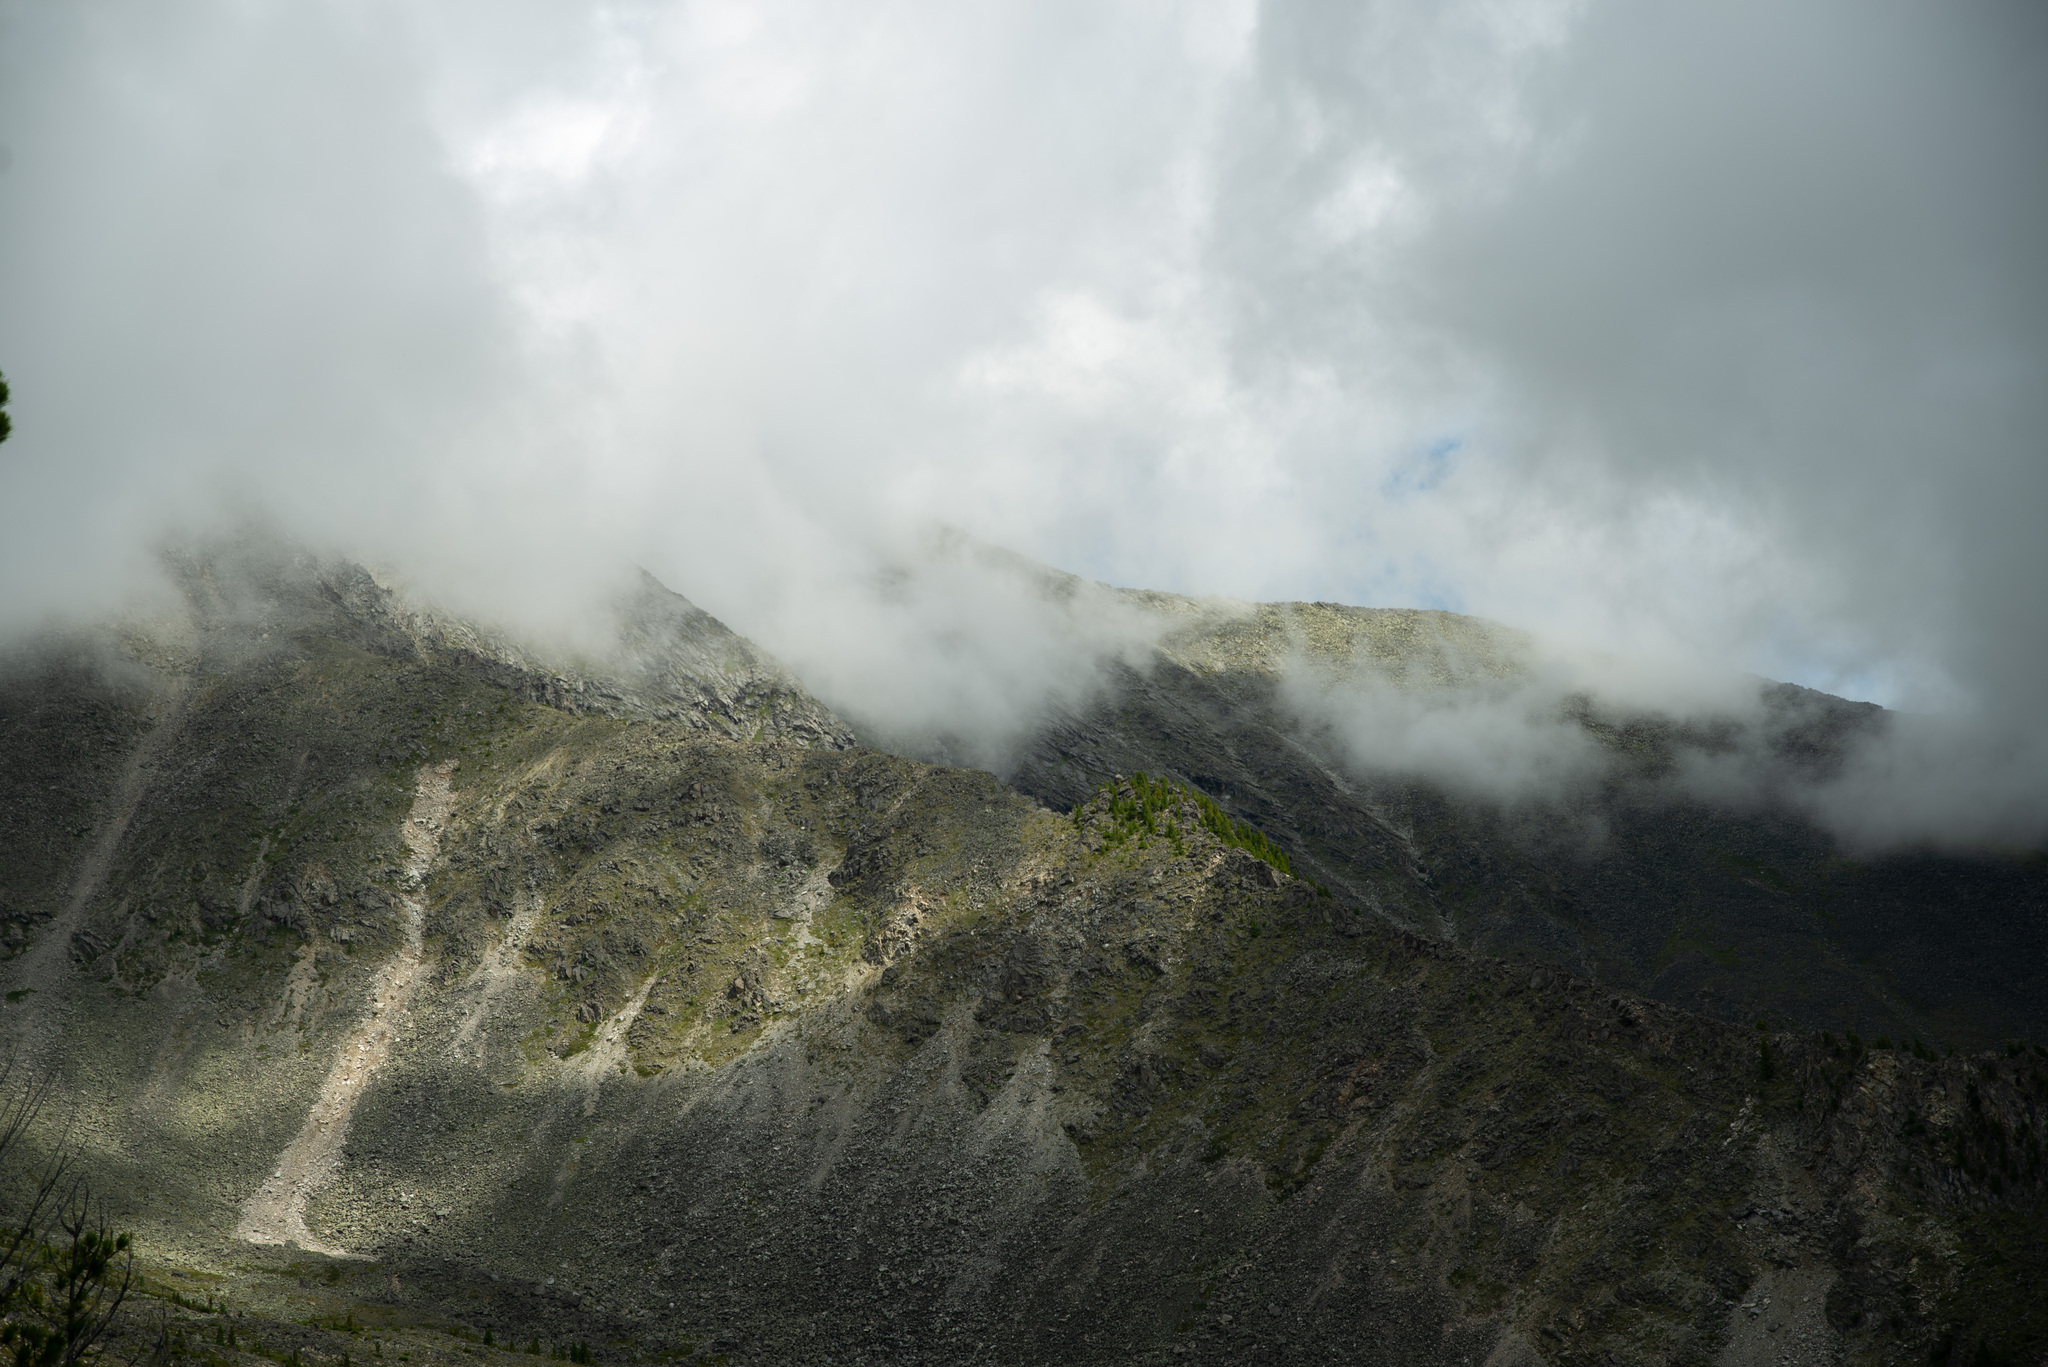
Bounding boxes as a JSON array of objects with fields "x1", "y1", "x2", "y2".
[{"x1": 0, "y1": 0, "x2": 2048, "y2": 836}]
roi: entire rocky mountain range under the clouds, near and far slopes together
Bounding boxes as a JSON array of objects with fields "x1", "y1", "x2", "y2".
[{"x1": 0, "y1": 547, "x2": 2048, "y2": 1367}]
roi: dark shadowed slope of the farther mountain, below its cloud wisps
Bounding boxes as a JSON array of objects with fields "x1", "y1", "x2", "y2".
[{"x1": 1012, "y1": 627, "x2": 2048, "y2": 1047}]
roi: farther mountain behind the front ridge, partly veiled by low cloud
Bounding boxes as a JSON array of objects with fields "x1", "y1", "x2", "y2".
[{"x1": 868, "y1": 537, "x2": 2048, "y2": 1047}]
